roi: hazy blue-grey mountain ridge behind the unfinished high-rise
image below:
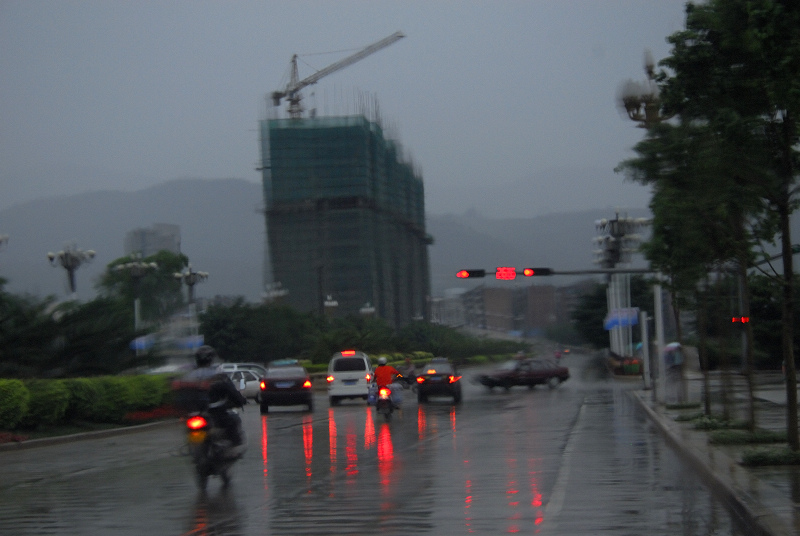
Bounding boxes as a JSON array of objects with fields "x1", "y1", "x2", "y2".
[{"x1": 0, "y1": 179, "x2": 647, "y2": 301}]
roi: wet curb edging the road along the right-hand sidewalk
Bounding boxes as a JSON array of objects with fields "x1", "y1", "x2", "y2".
[{"x1": 631, "y1": 391, "x2": 791, "y2": 536}]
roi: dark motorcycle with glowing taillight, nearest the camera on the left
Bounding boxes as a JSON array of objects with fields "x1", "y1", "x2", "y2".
[{"x1": 186, "y1": 411, "x2": 246, "y2": 490}]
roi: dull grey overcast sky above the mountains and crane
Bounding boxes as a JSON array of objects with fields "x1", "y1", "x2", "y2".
[{"x1": 0, "y1": 0, "x2": 685, "y2": 218}]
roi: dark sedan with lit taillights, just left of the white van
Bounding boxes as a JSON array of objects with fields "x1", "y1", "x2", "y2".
[{"x1": 259, "y1": 361, "x2": 314, "y2": 413}]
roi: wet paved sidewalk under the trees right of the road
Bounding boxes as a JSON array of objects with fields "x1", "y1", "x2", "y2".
[{"x1": 632, "y1": 375, "x2": 800, "y2": 536}]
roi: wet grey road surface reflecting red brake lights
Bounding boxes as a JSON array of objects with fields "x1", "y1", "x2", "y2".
[{"x1": 0, "y1": 355, "x2": 746, "y2": 535}]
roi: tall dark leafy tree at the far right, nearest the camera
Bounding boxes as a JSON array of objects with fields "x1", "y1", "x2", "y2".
[{"x1": 620, "y1": 0, "x2": 800, "y2": 444}]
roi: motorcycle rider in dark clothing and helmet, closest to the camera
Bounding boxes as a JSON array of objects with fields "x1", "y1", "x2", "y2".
[{"x1": 181, "y1": 345, "x2": 247, "y2": 452}]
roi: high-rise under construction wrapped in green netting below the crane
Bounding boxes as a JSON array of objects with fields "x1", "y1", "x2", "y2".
[{"x1": 260, "y1": 115, "x2": 431, "y2": 326}]
